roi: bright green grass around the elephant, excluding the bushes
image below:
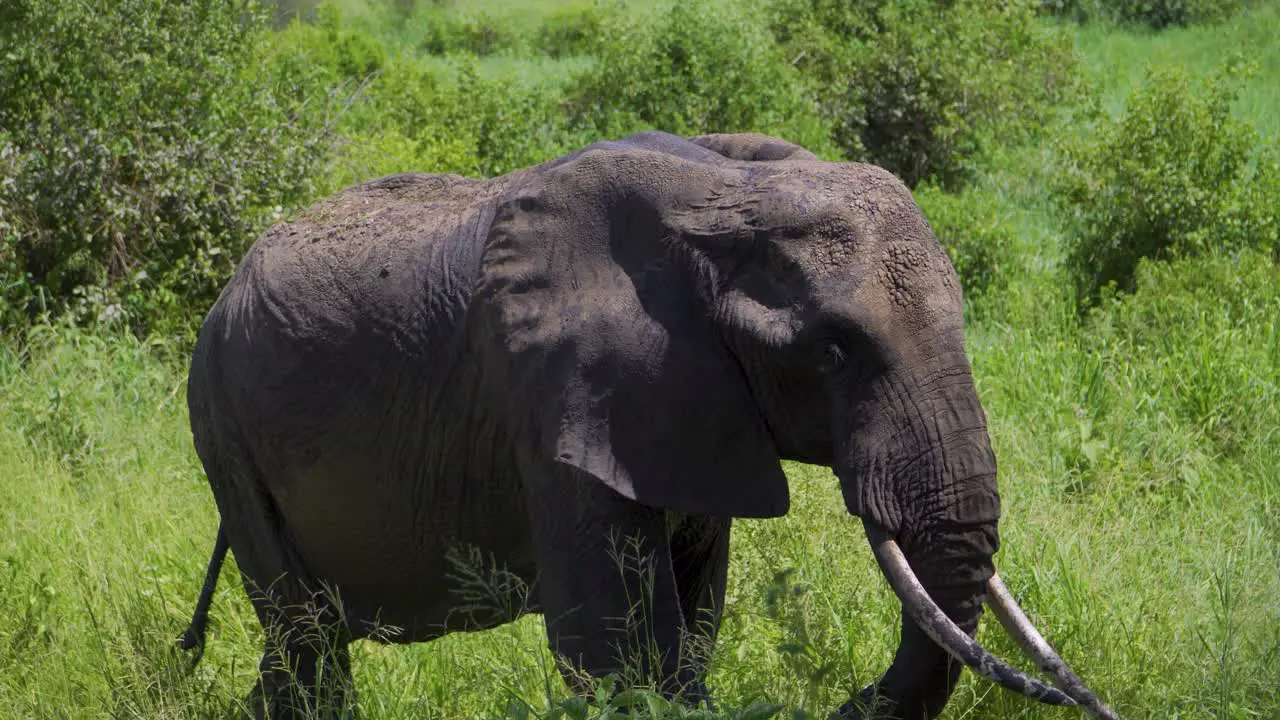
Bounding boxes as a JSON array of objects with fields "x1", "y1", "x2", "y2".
[{"x1": 0, "y1": 0, "x2": 1280, "y2": 720}]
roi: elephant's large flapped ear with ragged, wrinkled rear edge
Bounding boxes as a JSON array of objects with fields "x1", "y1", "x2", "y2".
[{"x1": 476, "y1": 150, "x2": 788, "y2": 518}]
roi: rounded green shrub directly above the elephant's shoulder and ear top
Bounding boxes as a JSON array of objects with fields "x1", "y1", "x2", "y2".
[{"x1": 567, "y1": 1, "x2": 831, "y2": 154}]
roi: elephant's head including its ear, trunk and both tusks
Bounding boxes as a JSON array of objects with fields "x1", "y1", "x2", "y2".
[{"x1": 481, "y1": 135, "x2": 1110, "y2": 720}]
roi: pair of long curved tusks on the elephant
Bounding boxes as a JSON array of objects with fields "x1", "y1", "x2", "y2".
[{"x1": 863, "y1": 520, "x2": 1120, "y2": 720}]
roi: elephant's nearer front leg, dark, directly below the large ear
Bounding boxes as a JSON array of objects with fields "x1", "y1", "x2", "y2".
[{"x1": 526, "y1": 469, "x2": 704, "y2": 697}]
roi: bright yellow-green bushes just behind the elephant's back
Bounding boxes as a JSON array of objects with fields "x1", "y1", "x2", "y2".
[{"x1": 271, "y1": 4, "x2": 599, "y2": 181}]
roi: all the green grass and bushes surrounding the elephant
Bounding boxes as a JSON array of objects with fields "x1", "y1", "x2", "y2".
[{"x1": 0, "y1": 0, "x2": 1280, "y2": 720}]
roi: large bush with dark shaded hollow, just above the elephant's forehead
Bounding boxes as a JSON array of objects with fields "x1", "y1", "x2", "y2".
[{"x1": 771, "y1": 0, "x2": 1079, "y2": 186}]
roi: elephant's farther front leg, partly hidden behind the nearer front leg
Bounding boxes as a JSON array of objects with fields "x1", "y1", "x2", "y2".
[{"x1": 671, "y1": 516, "x2": 732, "y2": 702}]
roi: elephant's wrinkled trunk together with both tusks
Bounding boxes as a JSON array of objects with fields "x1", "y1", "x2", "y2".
[{"x1": 841, "y1": 345, "x2": 1114, "y2": 720}]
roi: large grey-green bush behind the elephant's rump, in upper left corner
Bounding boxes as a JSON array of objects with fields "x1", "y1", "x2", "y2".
[{"x1": 0, "y1": 0, "x2": 325, "y2": 332}]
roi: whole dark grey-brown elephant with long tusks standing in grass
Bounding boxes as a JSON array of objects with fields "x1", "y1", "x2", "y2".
[{"x1": 180, "y1": 132, "x2": 1115, "y2": 720}]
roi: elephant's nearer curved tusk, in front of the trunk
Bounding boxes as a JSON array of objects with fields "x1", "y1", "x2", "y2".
[{"x1": 863, "y1": 521, "x2": 1076, "y2": 706}]
